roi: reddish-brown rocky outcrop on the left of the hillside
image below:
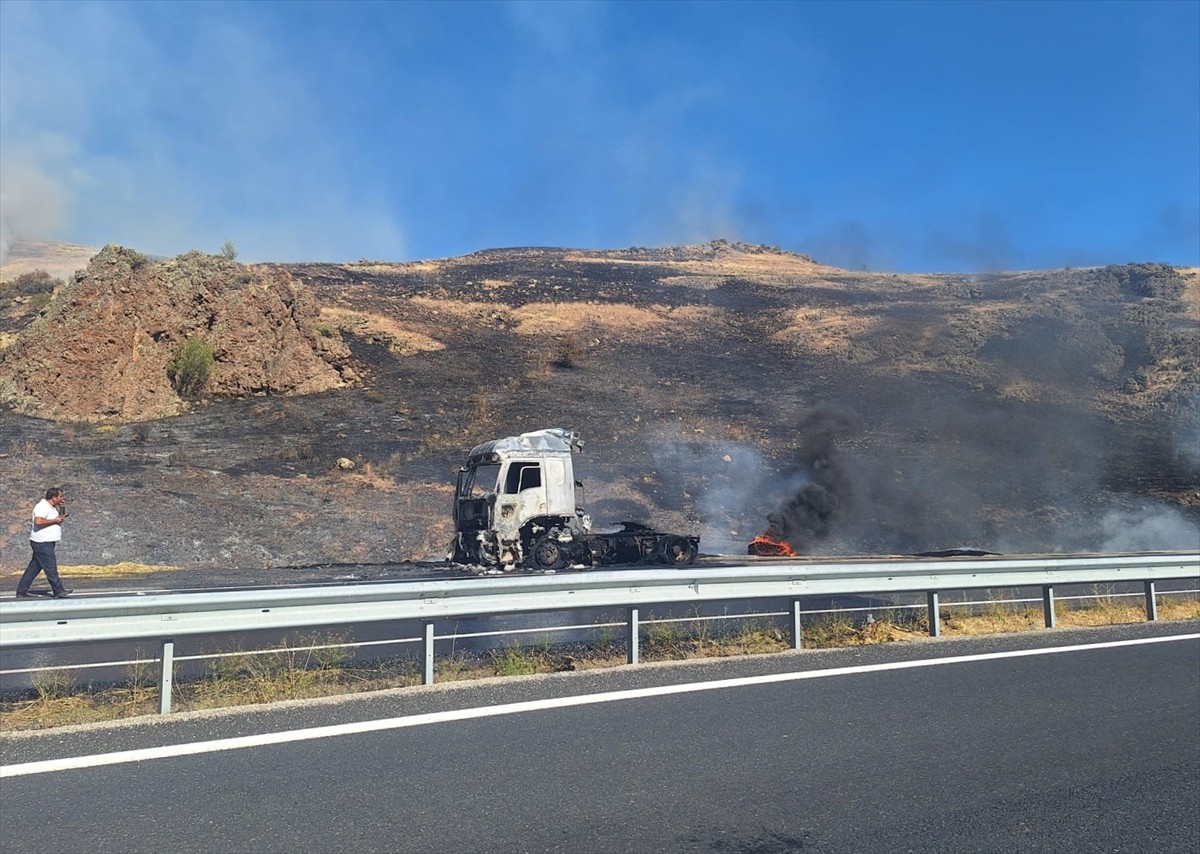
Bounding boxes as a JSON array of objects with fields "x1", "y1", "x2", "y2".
[{"x1": 0, "y1": 246, "x2": 356, "y2": 422}]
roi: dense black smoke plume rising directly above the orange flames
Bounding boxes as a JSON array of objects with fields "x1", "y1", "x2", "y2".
[{"x1": 764, "y1": 407, "x2": 862, "y2": 554}]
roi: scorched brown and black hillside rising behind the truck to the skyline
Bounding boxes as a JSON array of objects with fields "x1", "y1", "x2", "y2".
[{"x1": 0, "y1": 241, "x2": 1200, "y2": 578}]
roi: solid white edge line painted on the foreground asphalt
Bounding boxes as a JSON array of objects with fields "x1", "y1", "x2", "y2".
[{"x1": 0, "y1": 632, "x2": 1200, "y2": 777}]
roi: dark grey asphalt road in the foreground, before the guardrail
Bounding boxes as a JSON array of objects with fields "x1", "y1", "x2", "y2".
[{"x1": 0, "y1": 621, "x2": 1200, "y2": 854}]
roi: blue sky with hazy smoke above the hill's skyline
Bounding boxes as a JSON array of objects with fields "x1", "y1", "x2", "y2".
[{"x1": 0, "y1": 0, "x2": 1200, "y2": 272}]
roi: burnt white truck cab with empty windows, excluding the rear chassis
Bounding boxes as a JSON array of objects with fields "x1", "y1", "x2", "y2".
[{"x1": 451, "y1": 427, "x2": 589, "y2": 570}]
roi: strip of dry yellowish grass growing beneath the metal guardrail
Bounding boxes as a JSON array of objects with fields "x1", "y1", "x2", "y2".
[{"x1": 0, "y1": 597, "x2": 1200, "y2": 732}]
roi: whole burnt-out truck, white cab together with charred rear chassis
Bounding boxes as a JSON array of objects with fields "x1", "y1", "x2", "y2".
[{"x1": 448, "y1": 427, "x2": 700, "y2": 572}]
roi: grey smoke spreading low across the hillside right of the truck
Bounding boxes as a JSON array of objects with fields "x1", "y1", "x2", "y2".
[{"x1": 672, "y1": 399, "x2": 1200, "y2": 554}]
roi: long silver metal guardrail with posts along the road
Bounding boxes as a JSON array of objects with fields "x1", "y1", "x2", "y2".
[{"x1": 0, "y1": 552, "x2": 1200, "y2": 714}]
